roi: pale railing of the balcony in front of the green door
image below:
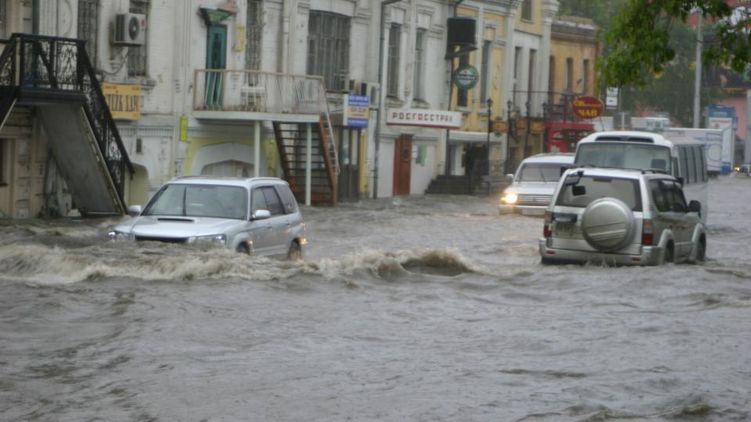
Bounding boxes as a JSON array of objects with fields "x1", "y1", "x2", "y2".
[{"x1": 193, "y1": 69, "x2": 327, "y2": 115}]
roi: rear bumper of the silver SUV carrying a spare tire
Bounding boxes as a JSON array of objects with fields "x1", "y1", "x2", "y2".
[{"x1": 539, "y1": 238, "x2": 663, "y2": 265}]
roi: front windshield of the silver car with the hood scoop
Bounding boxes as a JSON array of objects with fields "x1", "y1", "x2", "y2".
[{"x1": 142, "y1": 184, "x2": 248, "y2": 219}]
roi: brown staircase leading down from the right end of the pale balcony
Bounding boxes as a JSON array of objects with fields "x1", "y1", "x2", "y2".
[{"x1": 273, "y1": 115, "x2": 337, "y2": 205}]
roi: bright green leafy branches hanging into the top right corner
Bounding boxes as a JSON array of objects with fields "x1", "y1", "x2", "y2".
[{"x1": 599, "y1": 0, "x2": 740, "y2": 87}]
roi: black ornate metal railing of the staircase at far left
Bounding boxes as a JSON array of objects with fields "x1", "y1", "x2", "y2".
[{"x1": 0, "y1": 34, "x2": 133, "y2": 204}]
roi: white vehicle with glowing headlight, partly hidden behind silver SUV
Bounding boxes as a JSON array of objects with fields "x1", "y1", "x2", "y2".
[{"x1": 498, "y1": 153, "x2": 574, "y2": 215}]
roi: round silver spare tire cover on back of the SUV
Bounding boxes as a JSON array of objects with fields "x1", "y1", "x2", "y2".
[{"x1": 581, "y1": 198, "x2": 635, "y2": 251}]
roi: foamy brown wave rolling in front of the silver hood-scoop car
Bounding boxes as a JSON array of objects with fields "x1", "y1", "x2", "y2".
[{"x1": 0, "y1": 243, "x2": 480, "y2": 285}]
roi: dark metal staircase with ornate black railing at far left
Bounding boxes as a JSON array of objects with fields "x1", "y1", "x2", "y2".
[{"x1": 0, "y1": 34, "x2": 133, "y2": 215}]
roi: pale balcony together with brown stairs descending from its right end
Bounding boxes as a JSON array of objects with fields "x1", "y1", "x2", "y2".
[{"x1": 193, "y1": 69, "x2": 338, "y2": 205}]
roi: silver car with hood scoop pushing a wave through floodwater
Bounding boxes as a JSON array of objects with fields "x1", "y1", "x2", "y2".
[{"x1": 109, "y1": 176, "x2": 306, "y2": 259}]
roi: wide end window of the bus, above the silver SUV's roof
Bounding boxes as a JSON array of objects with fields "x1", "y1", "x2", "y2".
[{"x1": 574, "y1": 142, "x2": 672, "y2": 174}]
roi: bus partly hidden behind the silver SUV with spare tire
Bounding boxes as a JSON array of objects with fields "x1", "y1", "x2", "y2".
[{"x1": 574, "y1": 131, "x2": 709, "y2": 224}]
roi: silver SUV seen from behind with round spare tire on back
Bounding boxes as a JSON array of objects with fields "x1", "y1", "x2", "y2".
[{"x1": 539, "y1": 168, "x2": 707, "y2": 265}]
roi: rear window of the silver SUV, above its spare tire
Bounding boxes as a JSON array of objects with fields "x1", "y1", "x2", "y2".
[{"x1": 556, "y1": 175, "x2": 642, "y2": 211}]
